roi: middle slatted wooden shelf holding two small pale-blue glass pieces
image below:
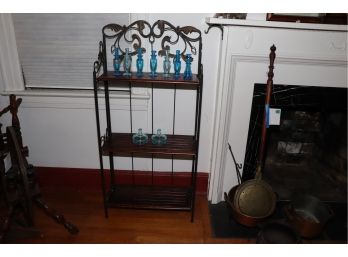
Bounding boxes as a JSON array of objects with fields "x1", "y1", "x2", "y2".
[{"x1": 102, "y1": 133, "x2": 197, "y2": 159}]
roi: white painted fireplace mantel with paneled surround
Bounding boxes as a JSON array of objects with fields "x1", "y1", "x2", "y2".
[{"x1": 206, "y1": 18, "x2": 347, "y2": 203}]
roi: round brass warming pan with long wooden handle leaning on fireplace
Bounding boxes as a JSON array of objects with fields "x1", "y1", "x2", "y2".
[{"x1": 225, "y1": 45, "x2": 276, "y2": 226}]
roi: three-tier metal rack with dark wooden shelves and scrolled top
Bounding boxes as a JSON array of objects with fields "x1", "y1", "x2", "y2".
[{"x1": 93, "y1": 20, "x2": 203, "y2": 222}]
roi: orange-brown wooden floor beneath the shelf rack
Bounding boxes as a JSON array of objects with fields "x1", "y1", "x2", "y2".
[{"x1": 6, "y1": 188, "x2": 255, "y2": 244}]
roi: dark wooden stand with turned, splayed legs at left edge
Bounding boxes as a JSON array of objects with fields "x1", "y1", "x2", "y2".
[{"x1": 0, "y1": 96, "x2": 79, "y2": 242}]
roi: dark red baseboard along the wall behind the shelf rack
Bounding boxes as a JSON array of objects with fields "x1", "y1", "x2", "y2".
[{"x1": 36, "y1": 167, "x2": 209, "y2": 194}]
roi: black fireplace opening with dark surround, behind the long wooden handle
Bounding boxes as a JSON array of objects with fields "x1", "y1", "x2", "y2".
[{"x1": 243, "y1": 84, "x2": 347, "y2": 203}]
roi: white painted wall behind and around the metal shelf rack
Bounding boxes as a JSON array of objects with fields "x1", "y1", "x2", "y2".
[{"x1": 0, "y1": 14, "x2": 220, "y2": 172}]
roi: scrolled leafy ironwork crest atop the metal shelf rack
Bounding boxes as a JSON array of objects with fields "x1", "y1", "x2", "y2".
[{"x1": 102, "y1": 20, "x2": 202, "y2": 60}]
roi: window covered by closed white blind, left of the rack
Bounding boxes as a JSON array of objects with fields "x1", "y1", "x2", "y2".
[{"x1": 12, "y1": 13, "x2": 130, "y2": 89}]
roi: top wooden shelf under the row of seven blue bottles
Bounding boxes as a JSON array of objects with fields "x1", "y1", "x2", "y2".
[{"x1": 97, "y1": 71, "x2": 200, "y2": 87}]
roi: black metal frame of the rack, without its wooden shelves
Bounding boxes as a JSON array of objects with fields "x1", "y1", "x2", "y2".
[{"x1": 93, "y1": 20, "x2": 203, "y2": 221}]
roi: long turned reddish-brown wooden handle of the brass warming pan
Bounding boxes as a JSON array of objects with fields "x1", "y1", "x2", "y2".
[{"x1": 255, "y1": 45, "x2": 276, "y2": 178}]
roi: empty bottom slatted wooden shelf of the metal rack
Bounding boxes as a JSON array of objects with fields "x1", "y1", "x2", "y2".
[{"x1": 107, "y1": 185, "x2": 192, "y2": 211}]
